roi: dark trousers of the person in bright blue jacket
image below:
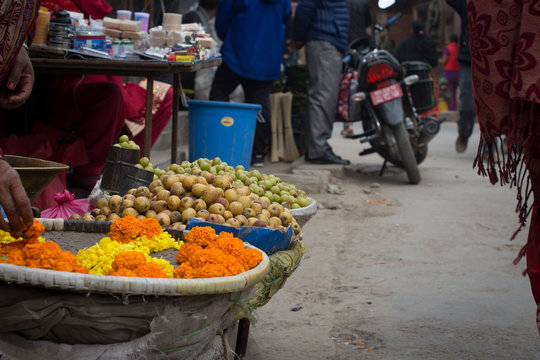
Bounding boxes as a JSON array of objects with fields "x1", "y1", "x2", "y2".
[{"x1": 210, "y1": 62, "x2": 273, "y2": 157}]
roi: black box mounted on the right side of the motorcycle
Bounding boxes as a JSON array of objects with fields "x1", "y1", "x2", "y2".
[{"x1": 402, "y1": 61, "x2": 437, "y2": 113}]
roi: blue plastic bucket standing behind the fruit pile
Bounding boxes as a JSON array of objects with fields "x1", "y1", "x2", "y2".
[{"x1": 188, "y1": 100, "x2": 262, "y2": 169}]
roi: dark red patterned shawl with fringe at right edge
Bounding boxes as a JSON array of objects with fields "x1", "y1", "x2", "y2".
[{"x1": 467, "y1": 0, "x2": 540, "y2": 330}]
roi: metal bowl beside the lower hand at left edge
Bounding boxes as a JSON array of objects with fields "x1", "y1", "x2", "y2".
[{"x1": 5, "y1": 155, "x2": 69, "y2": 202}]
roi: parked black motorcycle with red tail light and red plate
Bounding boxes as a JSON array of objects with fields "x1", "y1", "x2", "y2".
[{"x1": 343, "y1": 14, "x2": 444, "y2": 184}]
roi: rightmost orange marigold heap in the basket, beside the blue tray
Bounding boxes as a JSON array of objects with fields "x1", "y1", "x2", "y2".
[{"x1": 174, "y1": 226, "x2": 262, "y2": 279}]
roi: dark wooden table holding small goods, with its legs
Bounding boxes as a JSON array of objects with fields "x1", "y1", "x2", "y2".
[{"x1": 30, "y1": 45, "x2": 221, "y2": 163}]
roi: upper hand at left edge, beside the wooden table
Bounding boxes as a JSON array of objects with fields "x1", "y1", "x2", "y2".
[{"x1": 0, "y1": 49, "x2": 34, "y2": 109}]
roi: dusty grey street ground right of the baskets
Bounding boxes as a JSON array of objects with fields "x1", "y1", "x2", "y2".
[{"x1": 246, "y1": 123, "x2": 540, "y2": 360}]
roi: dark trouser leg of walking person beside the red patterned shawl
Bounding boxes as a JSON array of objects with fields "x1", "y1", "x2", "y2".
[{"x1": 458, "y1": 63, "x2": 476, "y2": 139}]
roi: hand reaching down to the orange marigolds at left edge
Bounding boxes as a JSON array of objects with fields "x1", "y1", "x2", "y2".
[{"x1": 0, "y1": 160, "x2": 34, "y2": 237}]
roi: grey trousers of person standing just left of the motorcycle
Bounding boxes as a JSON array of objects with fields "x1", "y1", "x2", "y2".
[{"x1": 305, "y1": 41, "x2": 341, "y2": 160}]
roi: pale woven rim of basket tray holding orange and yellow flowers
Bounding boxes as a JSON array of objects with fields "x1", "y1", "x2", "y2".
[{"x1": 0, "y1": 219, "x2": 270, "y2": 296}]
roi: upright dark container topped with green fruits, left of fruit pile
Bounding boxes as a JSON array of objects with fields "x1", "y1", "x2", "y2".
[{"x1": 101, "y1": 146, "x2": 140, "y2": 193}]
